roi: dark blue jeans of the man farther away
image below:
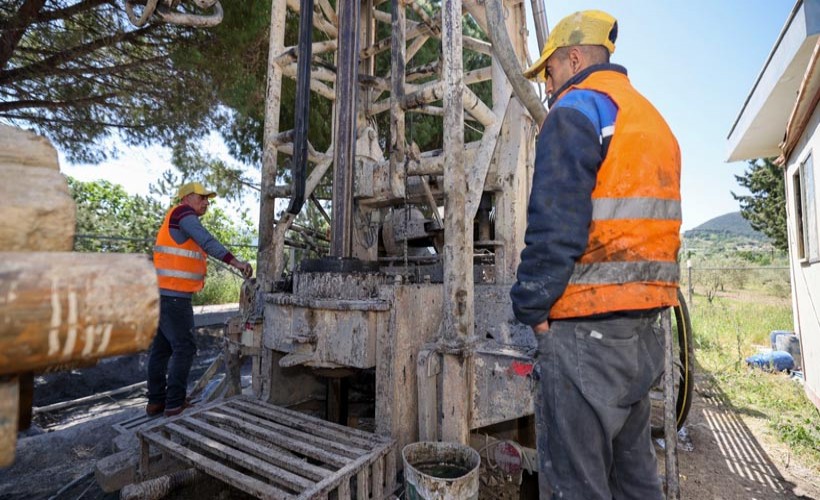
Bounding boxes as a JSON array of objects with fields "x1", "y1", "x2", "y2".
[{"x1": 148, "y1": 295, "x2": 196, "y2": 408}]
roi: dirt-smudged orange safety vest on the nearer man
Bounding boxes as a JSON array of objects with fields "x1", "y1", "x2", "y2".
[{"x1": 550, "y1": 71, "x2": 681, "y2": 319}]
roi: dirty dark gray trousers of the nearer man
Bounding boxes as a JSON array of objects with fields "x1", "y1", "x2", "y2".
[{"x1": 535, "y1": 311, "x2": 664, "y2": 500}]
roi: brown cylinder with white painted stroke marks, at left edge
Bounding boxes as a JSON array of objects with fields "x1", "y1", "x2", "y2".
[{"x1": 0, "y1": 252, "x2": 159, "y2": 375}]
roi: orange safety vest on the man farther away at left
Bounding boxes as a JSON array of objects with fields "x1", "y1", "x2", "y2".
[{"x1": 154, "y1": 205, "x2": 208, "y2": 293}]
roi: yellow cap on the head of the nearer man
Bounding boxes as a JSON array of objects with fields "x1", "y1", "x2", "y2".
[{"x1": 524, "y1": 10, "x2": 618, "y2": 80}]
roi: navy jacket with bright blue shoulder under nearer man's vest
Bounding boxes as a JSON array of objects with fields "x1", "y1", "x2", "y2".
[{"x1": 510, "y1": 64, "x2": 626, "y2": 326}]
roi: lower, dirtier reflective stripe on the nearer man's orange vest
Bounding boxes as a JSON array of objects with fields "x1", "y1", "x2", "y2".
[{"x1": 569, "y1": 261, "x2": 680, "y2": 285}]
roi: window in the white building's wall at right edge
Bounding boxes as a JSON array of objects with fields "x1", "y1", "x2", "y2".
[{"x1": 792, "y1": 155, "x2": 820, "y2": 262}]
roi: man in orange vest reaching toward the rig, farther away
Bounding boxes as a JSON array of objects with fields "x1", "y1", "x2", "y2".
[{"x1": 145, "y1": 182, "x2": 253, "y2": 417}]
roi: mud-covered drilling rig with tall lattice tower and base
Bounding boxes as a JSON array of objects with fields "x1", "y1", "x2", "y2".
[{"x1": 244, "y1": 0, "x2": 546, "y2": 456}]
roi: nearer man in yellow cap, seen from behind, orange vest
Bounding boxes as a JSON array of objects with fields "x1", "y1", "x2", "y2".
[{"x1": 510, "y1": 10, "x2": 681, "y2": 500}]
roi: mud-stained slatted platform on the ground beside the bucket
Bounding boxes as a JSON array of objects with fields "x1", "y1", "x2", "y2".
[{"x1": 138, "y1": 396, "x2": 396, "y2": 500}]
